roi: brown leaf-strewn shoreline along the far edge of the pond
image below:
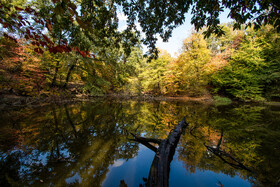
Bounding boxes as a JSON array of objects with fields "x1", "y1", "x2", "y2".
[{"x1": 0, "y1": 94, "x2": 280, "y2": 110}]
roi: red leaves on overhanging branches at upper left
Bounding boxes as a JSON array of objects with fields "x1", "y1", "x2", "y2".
[{"x1": 0, "y1": 4, "x2": 95, "y2": 58}]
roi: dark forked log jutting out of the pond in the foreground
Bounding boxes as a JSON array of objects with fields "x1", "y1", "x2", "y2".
[{"x1": 132, "y1": 117, "x2": 188, "y2": 187}]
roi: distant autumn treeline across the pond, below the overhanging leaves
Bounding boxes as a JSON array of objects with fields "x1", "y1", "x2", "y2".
[{"x1": 0, "y1": 23, "x2": 280, "y2": 101}]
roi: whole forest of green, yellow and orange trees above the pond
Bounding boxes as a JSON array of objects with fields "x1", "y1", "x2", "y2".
[{"x1": 0, "y1": 0, "x2": 280, "y2": 102}]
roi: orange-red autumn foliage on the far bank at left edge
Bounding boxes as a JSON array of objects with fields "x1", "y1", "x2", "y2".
[{"x1": 0, "y1": 38, "x2": 47, "y2": 96}]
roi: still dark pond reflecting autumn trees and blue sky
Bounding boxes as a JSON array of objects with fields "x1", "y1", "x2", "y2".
[{"x1": 0, "y1": 100, "x2": 280, "y2": 187}]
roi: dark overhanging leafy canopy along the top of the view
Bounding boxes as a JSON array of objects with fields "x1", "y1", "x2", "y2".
[{"x1": 0, "y1": 0, "x2": 280, "y2": 56}]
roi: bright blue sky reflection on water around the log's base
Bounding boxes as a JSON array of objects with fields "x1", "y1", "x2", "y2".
[{"x1": 102, "y1": 145, "x2": 251, "y2": 187}]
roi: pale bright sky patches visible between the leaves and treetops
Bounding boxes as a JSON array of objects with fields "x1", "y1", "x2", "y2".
[{"x1": 118, "y1": 9, "x2": 232, "y2": 57}]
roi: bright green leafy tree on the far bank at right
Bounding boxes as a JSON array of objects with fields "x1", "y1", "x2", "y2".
[{"x1": 212, "y1": 27, "x2": 279, "y2": 101}]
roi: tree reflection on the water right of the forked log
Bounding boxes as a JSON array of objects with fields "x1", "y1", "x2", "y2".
[{"x1": 178, "y1": 105, "x2": 280, "y2": 186}]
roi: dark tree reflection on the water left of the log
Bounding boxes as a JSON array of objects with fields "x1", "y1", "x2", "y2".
[{"x1": 0, "y1": 103, "x2": 141, "y2": 186}]
